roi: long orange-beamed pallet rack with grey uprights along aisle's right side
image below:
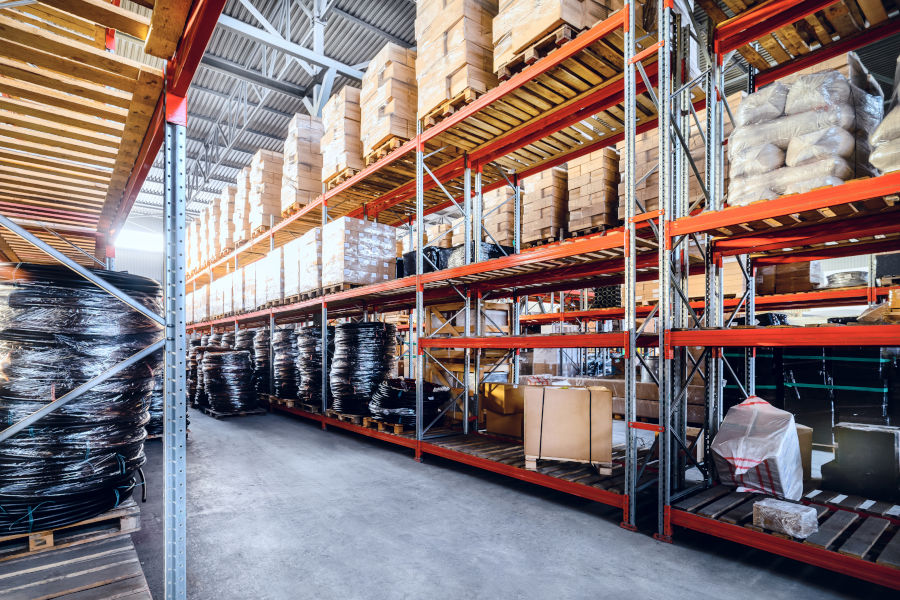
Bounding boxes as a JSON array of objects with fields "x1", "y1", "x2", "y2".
[{"x1": 188, "y1": 0, "x2": 900, "y2": 587}]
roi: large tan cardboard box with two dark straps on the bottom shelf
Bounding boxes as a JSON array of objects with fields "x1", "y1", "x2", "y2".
[{"x1": 525, "y1": 385, "x2": 612, "y2": 469}]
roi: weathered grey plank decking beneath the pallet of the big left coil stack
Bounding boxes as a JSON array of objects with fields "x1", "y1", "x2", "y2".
[{"x1": 0, "y1": 534, "x2": 151, "y2": 600}]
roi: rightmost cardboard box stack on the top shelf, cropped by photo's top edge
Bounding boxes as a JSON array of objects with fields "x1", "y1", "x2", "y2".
[{"x1": 493, "y1": 0, "x2": 622, "y2": 73}]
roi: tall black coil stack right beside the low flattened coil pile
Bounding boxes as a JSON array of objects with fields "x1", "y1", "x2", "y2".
[{"x1": 329, "y1": 322, "x2": 396, "y2": 415}]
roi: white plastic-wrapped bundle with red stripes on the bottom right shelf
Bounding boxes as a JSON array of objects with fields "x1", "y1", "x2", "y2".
[{"x1": 710, "y1": 396, "x2": 803, "y2": 500}]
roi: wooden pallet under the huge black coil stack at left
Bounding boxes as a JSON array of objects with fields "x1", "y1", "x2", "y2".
[{"x1": 0, "y1": 498, "x2": 141, "y2": 564}]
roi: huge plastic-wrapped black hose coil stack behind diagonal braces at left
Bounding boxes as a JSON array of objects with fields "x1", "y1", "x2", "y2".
[{"x1": 0, "y1": 263, "x2": 163, "y2": 535}]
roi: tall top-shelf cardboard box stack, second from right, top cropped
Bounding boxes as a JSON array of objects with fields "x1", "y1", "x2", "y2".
[{"x1": 416, "y1": 0, "x2": 497, "y2": 119}]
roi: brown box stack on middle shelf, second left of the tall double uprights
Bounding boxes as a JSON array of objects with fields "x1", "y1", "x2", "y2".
[{"x1": 522, "y1": 167, "x2": 568, "y2": 243}]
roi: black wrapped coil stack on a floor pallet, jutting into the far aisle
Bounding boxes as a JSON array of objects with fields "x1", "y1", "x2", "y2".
[{"x1": 203, "y1": 350, "x2": 257, "y2": 414}]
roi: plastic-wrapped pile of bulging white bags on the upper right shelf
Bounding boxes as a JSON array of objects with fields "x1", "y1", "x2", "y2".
[{"x1": 728, "y1": 56, "x2": 883, "y2": 206}]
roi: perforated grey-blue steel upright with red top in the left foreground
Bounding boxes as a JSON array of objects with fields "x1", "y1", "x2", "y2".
[{"x1": 163, "y1": 94, "x2": 187, "y2": 600}]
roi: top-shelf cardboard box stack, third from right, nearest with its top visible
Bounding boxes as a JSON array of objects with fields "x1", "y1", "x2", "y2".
[{"x1": 360, "y1": 44, "x2": 416, "y2": 164}]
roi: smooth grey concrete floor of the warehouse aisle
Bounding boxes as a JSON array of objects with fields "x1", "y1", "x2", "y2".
[{"x1": 133, "y1": 412, "x2": 896, "y2": 600}]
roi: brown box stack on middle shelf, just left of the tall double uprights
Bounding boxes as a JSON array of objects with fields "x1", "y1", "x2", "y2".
[{"x1": 568, "y1": 148, "x2": 619, "y2": 234}]
